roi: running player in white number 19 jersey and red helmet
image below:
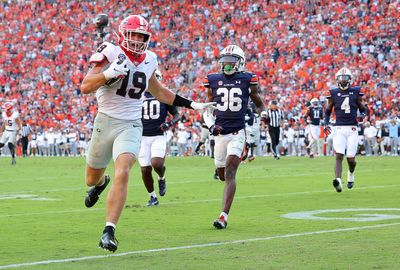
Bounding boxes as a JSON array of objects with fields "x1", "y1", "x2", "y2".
[{"x1": 81, "y1": 15, "x2": 214, "y2": 252}]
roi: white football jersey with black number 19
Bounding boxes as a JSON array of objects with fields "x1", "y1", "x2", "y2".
[{"x1": 91, "y1": 42, "x2": 158, "y2": 120}]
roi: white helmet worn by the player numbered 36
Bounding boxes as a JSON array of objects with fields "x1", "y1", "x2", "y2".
[{"x1": 219, "y1": 45, "x2": 246, "y2": 75}]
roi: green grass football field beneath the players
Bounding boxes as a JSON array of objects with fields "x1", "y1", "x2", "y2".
[{"x1": 0, "y1": 157, "x2": 400, "y2": 270}]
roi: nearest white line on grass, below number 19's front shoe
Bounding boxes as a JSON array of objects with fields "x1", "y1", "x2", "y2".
[{"x1": 0, "y1": 222, "x2": 400, "y2": 269}]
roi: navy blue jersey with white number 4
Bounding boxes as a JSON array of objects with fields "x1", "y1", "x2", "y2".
[{"x1": 327, "y1": 86, "x2": 363, "y2": 126}]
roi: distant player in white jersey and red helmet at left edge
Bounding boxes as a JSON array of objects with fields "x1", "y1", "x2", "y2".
[{"x1": 0, "y1": 102, "x2": 21, "y2": 165}]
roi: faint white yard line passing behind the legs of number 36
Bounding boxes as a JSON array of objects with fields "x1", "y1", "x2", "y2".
[{"x1": 0, "y1": 185, "x2": 400, "y2": 219}]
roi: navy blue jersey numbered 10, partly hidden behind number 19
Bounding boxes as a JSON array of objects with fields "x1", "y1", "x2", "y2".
[{"x1": 142, "y1": 92, "x2": 178, "y2": 136}]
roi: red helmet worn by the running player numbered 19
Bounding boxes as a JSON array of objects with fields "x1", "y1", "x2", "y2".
[{"x1": 118, "y1": 15, "x2": 151, "y2": 54}]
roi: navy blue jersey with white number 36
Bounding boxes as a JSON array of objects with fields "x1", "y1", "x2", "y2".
[{"x1": 204, "y1": 72, "x2": 258, "y2": 134}]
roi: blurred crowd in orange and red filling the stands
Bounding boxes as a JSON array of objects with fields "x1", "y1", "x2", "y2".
[{"x1": 0, "y1": 0, "x2": 400, "y2": 156}]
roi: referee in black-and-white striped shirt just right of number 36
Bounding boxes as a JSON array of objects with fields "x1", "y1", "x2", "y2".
[{"x1": 266, "y1": 100, "x2": 283, "y2": 159}]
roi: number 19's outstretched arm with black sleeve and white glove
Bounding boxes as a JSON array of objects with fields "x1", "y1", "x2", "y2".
[{"x1": 148, "y1": 73, "x2": 215, "y2": 110}]
